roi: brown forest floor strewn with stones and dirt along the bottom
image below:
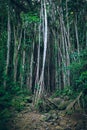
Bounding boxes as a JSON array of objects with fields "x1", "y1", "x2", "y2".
[{"x1": 9, "y1": 96, "x2": 87, "y2": 130}]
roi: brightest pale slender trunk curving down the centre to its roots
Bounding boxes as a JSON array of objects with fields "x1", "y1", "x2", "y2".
[{"x1": 35, "y1": 0, "x2": 47, "y2": 103}]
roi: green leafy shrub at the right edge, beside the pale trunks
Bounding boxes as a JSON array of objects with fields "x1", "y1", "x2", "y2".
[{"x1": 70, "y1": 49, "x2": 87, "y2": 91}]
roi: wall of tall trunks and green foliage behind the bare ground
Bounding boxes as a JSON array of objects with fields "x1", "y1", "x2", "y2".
[{"x1": 0, "y1": 0, "x2": 87, "y2": 130}]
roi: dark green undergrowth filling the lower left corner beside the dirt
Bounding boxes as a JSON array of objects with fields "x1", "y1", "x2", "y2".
[{"x1": 0, "y1": 84, "x2": 31, "y2": 130}]
